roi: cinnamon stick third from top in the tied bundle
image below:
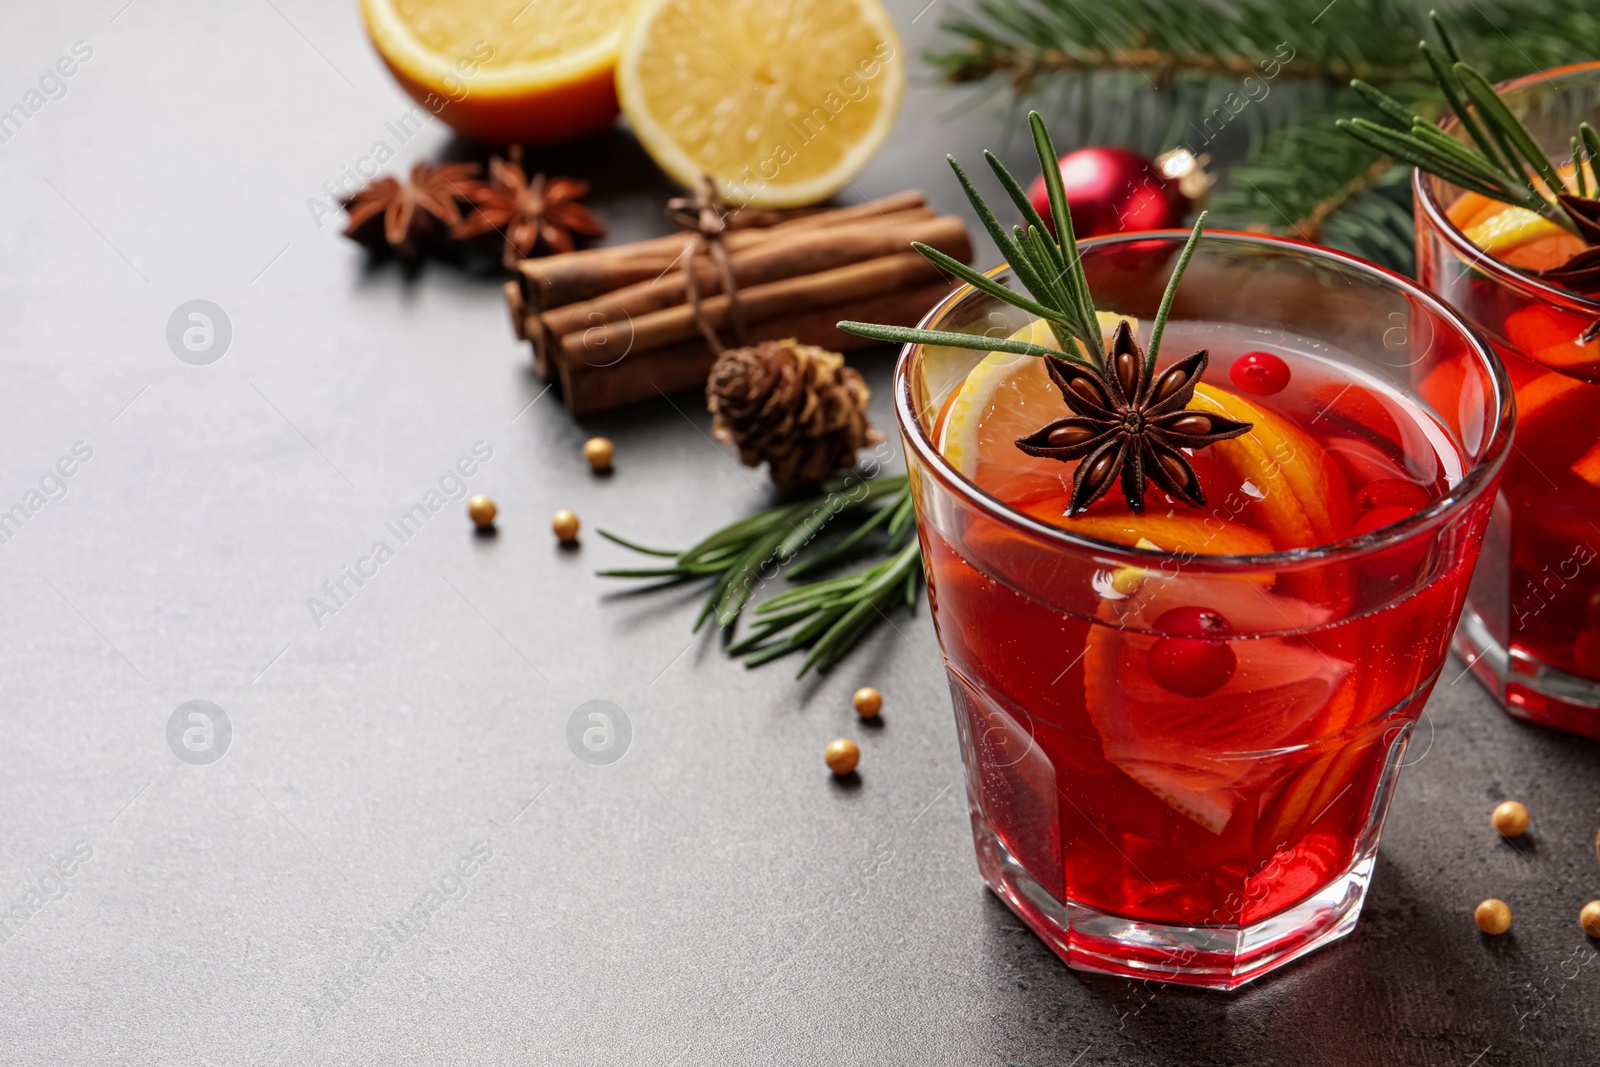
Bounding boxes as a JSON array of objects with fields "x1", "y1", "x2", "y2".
[{"x1": 552, "y1": 251, "x2": 944, "y2": 363}]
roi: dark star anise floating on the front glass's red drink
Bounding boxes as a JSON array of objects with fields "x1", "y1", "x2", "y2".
[{"x1": 1016, "y1": 320, "x2": 1251, "y2": 515}]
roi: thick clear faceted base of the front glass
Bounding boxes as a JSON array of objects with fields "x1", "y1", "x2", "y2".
[{"x1": 973, "y1": 813, "x2": 1378, "y2": 990}]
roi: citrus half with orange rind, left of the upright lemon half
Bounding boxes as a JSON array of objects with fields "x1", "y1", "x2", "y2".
[{"x1": 362, "y1": 0, "x2": 637, "y2": 144}]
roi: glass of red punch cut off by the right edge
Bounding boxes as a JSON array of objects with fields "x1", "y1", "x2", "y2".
[{"x1": 1416, "y1": 64, "x2": 1600, "y2": 737}]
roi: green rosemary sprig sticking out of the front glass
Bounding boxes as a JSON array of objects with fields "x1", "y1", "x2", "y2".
[{"x1": 838, "y1": 110, "x2": 1205, "y2": 373}]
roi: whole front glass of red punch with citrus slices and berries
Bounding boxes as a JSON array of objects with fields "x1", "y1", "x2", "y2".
[{"x1": 896, "y1": 234, "x2": 1510, "y2": 989}]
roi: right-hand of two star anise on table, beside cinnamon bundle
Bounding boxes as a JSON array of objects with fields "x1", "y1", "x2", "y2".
[{"x1": 453, "y1": 144, "x2": 605, "y2": 267}]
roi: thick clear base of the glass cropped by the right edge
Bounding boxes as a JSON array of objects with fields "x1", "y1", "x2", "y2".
[{"x1": 1453, "y1": 606, "x2": 1600, "y2": 739}]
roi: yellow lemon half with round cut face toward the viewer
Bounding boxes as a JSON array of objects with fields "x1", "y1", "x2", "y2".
[{"x1": 616, "y1": 0, "x2": 909, "y2": 206}]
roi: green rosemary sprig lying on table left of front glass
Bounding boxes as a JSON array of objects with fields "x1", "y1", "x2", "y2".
[{"x1": 600, "y1": 474, "x2": 922, "y2": 677}]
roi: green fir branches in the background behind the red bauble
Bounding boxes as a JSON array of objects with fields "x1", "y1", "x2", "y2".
[{"x1": 926, "y1": 0, "x2": 1600, "y2": 270}]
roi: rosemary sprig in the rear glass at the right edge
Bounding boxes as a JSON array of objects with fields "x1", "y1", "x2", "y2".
[{"x1": 1336, "y1": 11, "x2": 1600, "y2": 245}]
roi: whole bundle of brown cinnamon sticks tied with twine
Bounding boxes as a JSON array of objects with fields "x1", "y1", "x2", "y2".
[{"x1": 506, "y1": 190, "x2": 973, "y2": 414}]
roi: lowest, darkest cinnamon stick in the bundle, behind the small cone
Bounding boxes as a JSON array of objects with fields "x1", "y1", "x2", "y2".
[{"x1": 560, "y1": 278, "x2": 954, "y2": 414}]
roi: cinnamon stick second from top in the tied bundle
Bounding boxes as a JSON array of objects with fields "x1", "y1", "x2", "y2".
[{"x1": 537, "y1": 214, "x2": 973, "y2": 363}]
